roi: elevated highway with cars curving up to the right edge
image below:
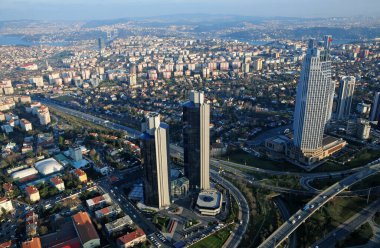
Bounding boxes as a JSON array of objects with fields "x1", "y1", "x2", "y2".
[{"x1": 259, "y1": 163, "x2": 380, "y2": 248}]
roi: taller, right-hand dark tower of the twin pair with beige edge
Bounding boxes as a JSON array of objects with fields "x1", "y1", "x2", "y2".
[{"x1": 183, "y1": 91, "x2": 210, "y2": 190}]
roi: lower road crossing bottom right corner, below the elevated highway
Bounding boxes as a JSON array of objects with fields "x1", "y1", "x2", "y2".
[{"x1": 311, "y1": 199, "x2": 380, "y2": 248}]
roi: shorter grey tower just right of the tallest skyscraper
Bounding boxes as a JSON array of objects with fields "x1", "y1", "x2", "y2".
[{"x1": 336, "y1": 76, "x2": 355, "y2": 120}]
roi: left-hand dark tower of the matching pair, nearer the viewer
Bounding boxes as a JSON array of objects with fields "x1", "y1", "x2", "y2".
[{"x1": 141, "y1": 113, "x2": 170, "y2": 208}]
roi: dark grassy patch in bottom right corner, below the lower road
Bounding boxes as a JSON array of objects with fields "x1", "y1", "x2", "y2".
[{"x1": 336, "y1": 222, "x2": 373, "y2": 248}]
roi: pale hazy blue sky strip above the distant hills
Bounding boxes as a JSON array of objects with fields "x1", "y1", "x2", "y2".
[{"x1": 0, "y1": 0, "x2": 380, "y2": 20}]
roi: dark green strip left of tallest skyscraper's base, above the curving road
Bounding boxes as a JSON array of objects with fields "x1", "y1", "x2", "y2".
[{"x1": 222, "y1": 149, "x2": 304, "y2": 172}]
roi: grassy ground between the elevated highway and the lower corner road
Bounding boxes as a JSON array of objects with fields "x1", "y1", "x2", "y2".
[{"x1": 298, "y1": 197, "x2": 367, "y2": 247}]
